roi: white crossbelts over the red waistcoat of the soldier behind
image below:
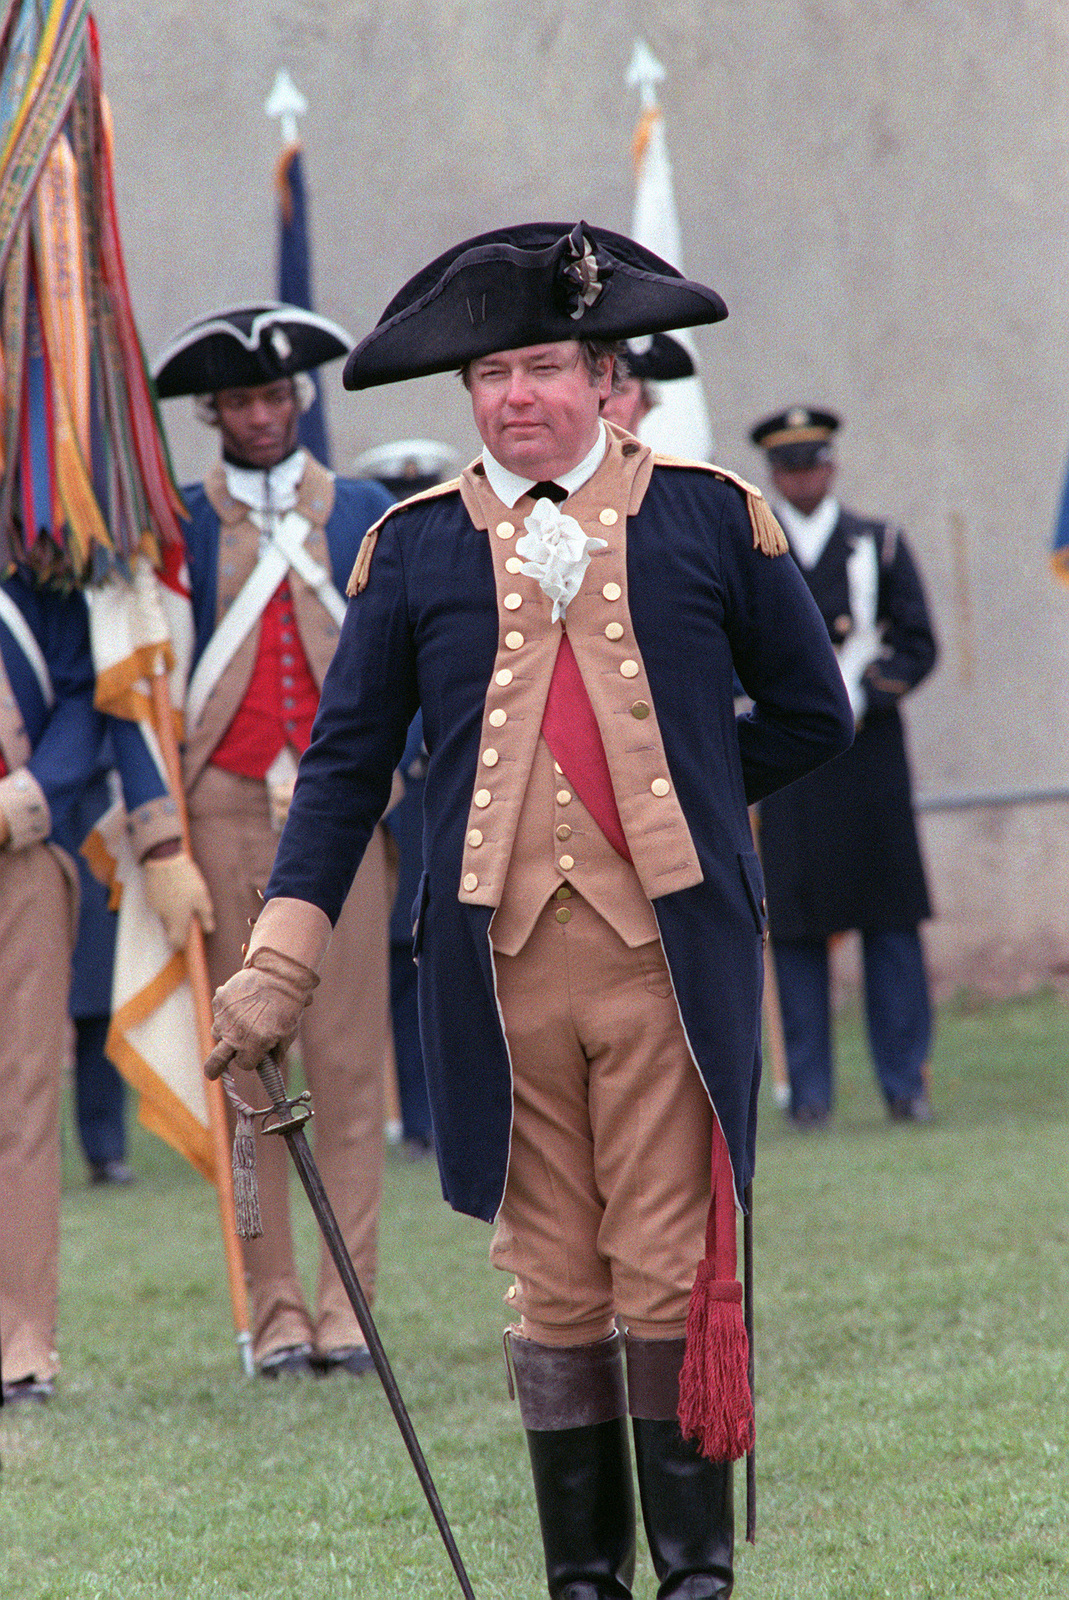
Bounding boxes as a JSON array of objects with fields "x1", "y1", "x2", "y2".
[{"x1": 186, "y1": 510, "x2": 346, "y2": 730}]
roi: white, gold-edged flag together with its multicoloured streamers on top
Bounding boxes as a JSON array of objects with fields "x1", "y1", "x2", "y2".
[{"x1": 0, "y1": 0, "x2": 214, "y2": 1178}]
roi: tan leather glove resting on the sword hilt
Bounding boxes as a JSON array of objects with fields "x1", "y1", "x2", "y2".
[{"x1": 205, "y1": 944, "x2": 318, "y2": 1078}]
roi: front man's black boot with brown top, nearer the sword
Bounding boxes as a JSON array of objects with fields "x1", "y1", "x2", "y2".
[{"x1": 509, "y1": 1334, "x2": 635, "y2": 1600}]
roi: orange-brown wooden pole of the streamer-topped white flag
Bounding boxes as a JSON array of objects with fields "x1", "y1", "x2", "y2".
[{"x1": 150, "y1": 653, "x2": 256, "y2": 1378}]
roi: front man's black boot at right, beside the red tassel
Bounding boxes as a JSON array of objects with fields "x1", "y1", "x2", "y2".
[{"x1": 627, "y1": 1338, "x2": 735, "y2": 1600}]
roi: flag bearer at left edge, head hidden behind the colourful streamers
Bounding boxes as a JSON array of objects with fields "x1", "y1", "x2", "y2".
[{"x1": 0, "y1": 571, "x2": 204, "y2": 1403}]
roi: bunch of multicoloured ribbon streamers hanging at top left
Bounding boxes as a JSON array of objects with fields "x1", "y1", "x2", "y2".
[{"x1": 0, "y1": 0, "x2": 181, "y2": 586}]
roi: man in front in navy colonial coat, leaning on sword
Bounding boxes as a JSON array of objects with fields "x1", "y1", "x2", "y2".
[{"x1": 200, "y1": 222, "x2": 851, "y2": 1600}]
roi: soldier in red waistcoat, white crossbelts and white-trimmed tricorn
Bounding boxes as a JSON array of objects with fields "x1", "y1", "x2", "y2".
[{"x1": 154, "y1": 304, "x2": 390, "y2": 1378}]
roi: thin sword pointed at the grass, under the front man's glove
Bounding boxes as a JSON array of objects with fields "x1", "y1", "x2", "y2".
[{"x1": 256, "y1": 1056, "x2": 475, "y2": 1600}]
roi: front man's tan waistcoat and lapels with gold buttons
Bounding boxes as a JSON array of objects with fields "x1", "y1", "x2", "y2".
[{"x1": 459, "y1": 430, "x2": 701, "y2": 952}]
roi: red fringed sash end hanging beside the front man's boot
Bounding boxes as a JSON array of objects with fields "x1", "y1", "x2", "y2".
[{"x1": 679, "y1": 1122, "x2": 754, "y2": 1461}]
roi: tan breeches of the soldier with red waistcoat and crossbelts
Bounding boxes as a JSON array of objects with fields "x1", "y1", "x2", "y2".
[{"x1": 189, "y1": 766, "x2": 389, "y2": 1360}]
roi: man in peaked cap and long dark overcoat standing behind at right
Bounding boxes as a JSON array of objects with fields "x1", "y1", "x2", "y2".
[{"x1": 751, "y1": 406, "x2": 936, "y2": 1128}]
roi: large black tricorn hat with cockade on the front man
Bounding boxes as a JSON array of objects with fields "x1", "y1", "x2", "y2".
[{"x1": 342, "y1": 222, "x2": 728, "y2": 389}]
